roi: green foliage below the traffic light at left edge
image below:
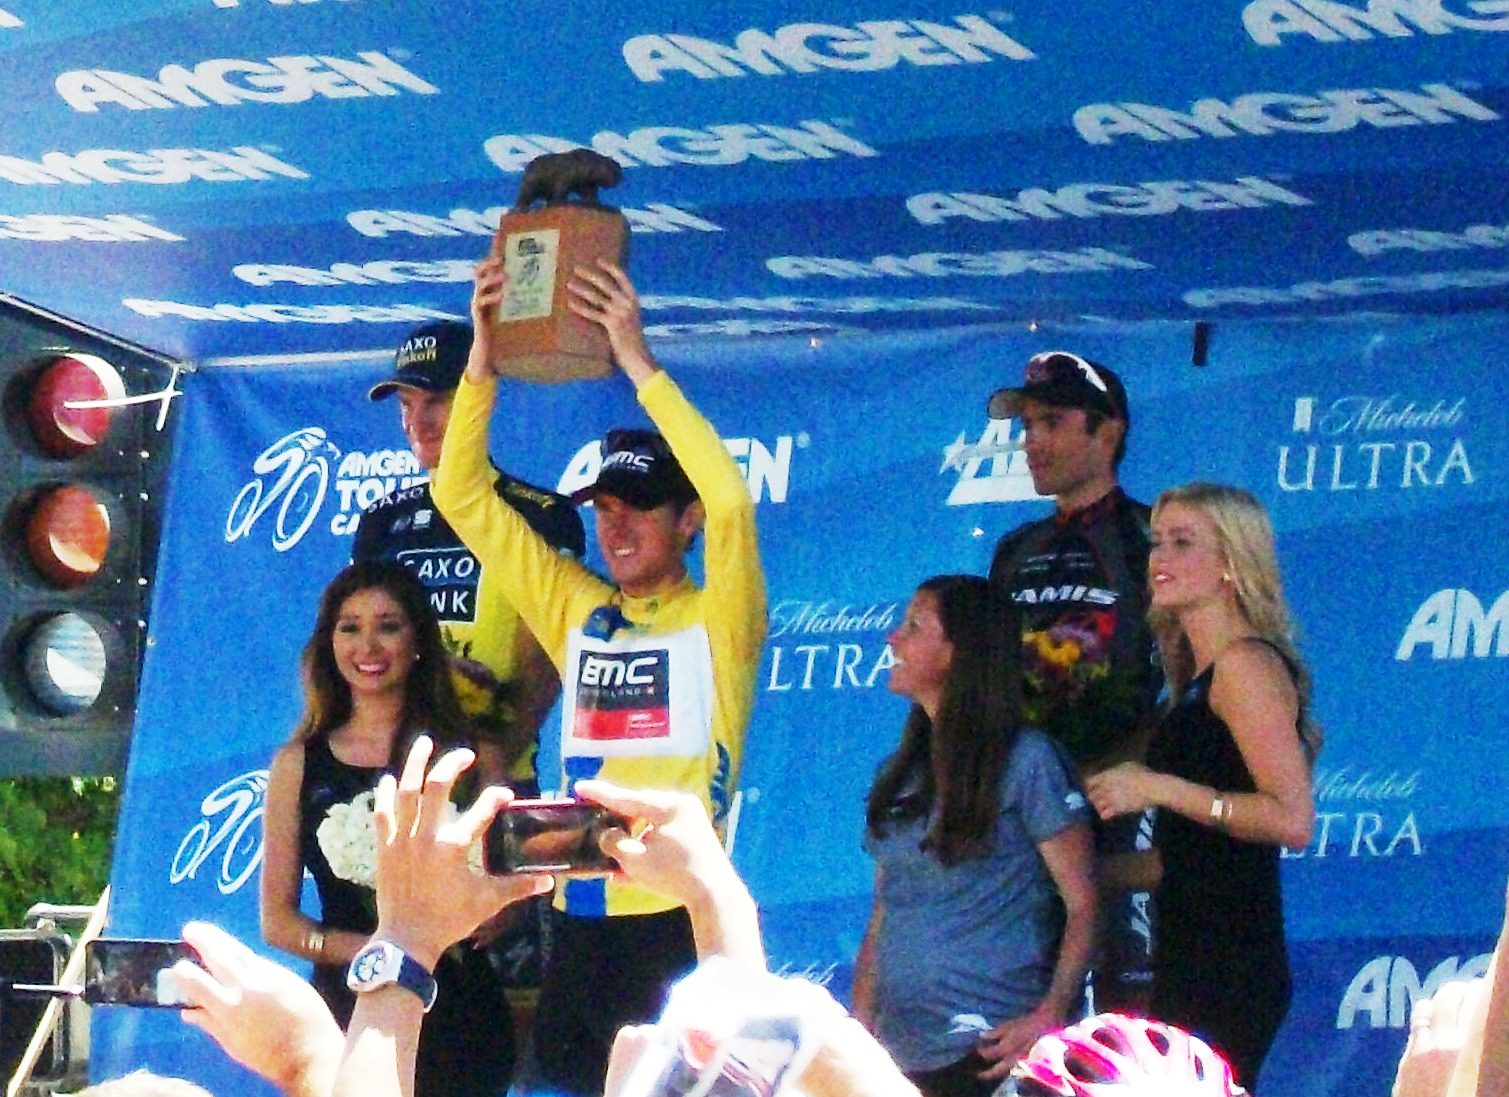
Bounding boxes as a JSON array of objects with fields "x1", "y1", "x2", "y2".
[{"x1": 0, "y1": 777, "x2": 121, "y2": 928}]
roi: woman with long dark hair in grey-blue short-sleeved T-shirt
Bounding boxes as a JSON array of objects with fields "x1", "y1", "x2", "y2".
[{"x1": 854, "y1": 575, "x2": 1097, "y2": 1097}]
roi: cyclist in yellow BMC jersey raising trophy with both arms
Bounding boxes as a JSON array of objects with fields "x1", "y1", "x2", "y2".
[{"x1": 432, "y1": 260, "x2": 765, "y2": 1097}]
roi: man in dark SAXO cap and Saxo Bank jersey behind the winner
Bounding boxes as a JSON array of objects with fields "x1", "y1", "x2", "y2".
[{"x1": 352, "y1": 320, "x2": 585, "y2": 795}]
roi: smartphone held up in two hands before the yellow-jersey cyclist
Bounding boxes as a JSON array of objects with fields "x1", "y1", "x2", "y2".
[{"x1": 483, "y1": 800, "x2": 629, "y2": 877}]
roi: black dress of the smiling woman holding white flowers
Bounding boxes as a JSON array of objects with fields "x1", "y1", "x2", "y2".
[{"x1": 299, "y1": 738, "x2": 515, "y2": 1097}]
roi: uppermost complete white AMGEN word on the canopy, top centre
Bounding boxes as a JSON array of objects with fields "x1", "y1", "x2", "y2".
[{"x1": 623, "y1": 15, "x2": 1037, "y2": 83}]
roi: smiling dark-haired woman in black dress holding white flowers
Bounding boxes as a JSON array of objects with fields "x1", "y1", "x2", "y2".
[{"x1": 261, "y1": 560, "x2": 513, "y2": 1097}]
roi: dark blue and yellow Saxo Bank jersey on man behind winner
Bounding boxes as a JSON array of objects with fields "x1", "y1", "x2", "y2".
[{"x1": 352, "y1": 469, "x2": 585, "y2": 782}]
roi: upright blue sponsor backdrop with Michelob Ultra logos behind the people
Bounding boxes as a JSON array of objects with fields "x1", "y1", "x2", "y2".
[{"x1": 94, "y1": 313, "x2": 1509, "y2": 1097}]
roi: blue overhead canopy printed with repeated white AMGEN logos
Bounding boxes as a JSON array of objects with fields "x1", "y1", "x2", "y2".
[{"x1": 0, "y1": 0, "x2": 1509, "y2": 359}]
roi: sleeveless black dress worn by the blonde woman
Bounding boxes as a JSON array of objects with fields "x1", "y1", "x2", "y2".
[{"x1": 1147, "y1": 668, "x2": 1298, "y2": 1089}]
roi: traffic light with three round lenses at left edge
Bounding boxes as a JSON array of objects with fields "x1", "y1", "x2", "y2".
[{"x1": 0, "y1": 304, "x2": 166, "y2": 776}]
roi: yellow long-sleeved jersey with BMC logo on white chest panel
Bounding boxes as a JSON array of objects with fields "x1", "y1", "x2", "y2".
[{"x1": 433, "y1": 373, "x2": 765, "y2": 914}]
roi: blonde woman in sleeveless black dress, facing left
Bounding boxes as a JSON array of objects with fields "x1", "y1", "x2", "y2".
[{"x1": 1086, "y1": 483, "x2": 1320, "y2": 1092}]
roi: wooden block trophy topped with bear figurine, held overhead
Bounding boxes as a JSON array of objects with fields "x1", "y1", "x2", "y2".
[{"x1": 492, "y1": 148, "x2": 629, "y2": 382}]
